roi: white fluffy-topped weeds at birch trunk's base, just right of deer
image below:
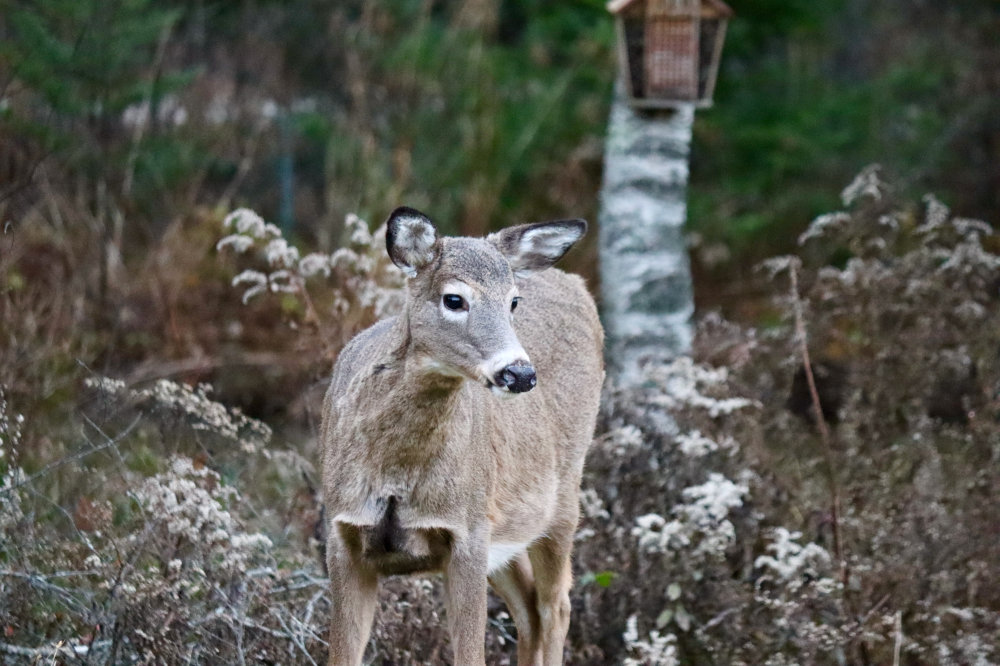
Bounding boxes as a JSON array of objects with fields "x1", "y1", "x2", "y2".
[{"x1": 571, "y1": 358, "x2": 757, "y2": 664}]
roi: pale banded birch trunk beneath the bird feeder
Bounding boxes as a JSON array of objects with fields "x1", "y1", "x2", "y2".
[{"x1": 599, "y1": 81, "x2": 694, "y2": 384}]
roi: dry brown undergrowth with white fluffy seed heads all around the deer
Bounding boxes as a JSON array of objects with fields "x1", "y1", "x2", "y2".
[{"x1": 0, "y1": 168, "x2": 1000, "y2": 665}]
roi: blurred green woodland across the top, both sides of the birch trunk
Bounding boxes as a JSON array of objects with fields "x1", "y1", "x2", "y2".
[{"x1": 0, "y1": 0, "x2": 1000, "y2": 268}]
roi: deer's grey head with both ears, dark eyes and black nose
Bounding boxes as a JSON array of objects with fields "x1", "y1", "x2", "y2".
[{"x1": 386, "y1": 207, "x2": 587, "y2": 395}]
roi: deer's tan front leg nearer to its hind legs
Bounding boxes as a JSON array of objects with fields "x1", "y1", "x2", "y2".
[{"x1": 444, "y1": 530, "x2": 489, "y2": 666}]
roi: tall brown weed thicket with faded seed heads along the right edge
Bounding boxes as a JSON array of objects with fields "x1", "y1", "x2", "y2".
[{"x1": 716, "y1": 167, "x2": 1000, "y2": 663}]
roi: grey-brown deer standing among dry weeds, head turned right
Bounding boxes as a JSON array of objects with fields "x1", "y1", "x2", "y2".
[{"x1": 319, "y1": 207, "x2": 604, "y2": 666}]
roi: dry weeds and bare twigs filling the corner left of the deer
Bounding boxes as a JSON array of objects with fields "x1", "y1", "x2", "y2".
[{"x1": 0, "y1": 377, "x2": 327, "y2": 664}]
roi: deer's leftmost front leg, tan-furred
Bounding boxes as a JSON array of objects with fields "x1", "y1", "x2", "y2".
[{"x1": 326, "y1": 525, "x2": 378, "y2": 666}]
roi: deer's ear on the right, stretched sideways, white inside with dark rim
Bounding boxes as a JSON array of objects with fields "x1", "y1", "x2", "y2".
[{"x1": 486, "y1": 220, "x2": 587, "y2": 277}]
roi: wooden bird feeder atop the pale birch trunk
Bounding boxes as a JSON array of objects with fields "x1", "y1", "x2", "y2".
[{"x1": 608, "y1": 0, "x2": 733, "y2": 109}]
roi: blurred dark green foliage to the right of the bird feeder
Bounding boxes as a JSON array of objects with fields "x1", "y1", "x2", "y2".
[{"x1": 690, "y1": 0, "x2": 1000, "y2": 264}]
